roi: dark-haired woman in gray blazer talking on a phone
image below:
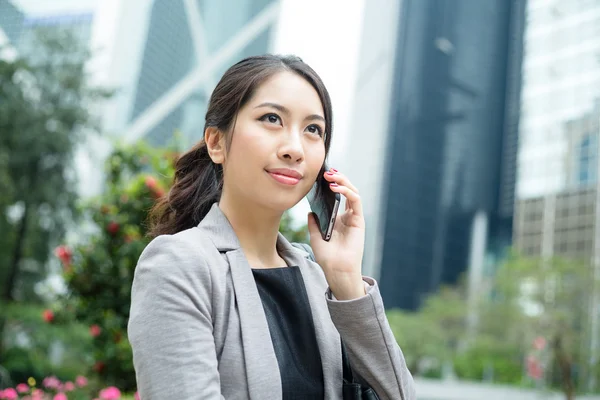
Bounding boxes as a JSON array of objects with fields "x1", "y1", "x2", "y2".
[{"x1": 129, "y1": 55, "x2": 415, "y2": 400}]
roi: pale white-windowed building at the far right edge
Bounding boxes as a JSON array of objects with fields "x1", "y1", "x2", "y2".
[{"x1": 515, "y1": 0, "x2": 600, "y2": 268}]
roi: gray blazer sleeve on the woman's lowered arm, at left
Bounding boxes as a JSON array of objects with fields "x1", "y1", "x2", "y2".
[{"x1": 128, "y1": 235, "x2": 223, "y2": 400}]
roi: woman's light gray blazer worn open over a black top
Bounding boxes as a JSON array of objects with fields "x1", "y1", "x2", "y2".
[{"x1": 128, "y1": 204, "x2": 416, "y2": 400}]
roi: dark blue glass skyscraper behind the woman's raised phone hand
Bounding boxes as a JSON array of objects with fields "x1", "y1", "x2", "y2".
[{"x1": 380, "y1": 0, "x2": 525, "y2": 309}]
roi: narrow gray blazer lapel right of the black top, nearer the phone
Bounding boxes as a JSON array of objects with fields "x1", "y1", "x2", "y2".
[{"x1": 277, "y1": 234, "x2": 343, "y2": 399}]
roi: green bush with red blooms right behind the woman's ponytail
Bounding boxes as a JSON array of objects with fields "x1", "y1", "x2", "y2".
[{"x1": 41, "y1": 143, "x2": 176, "y2": 392}]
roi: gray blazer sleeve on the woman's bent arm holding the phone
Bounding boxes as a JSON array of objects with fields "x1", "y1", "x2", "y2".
[{"x1": 326, "y1": 277, "x2": 417, "y2": 400}]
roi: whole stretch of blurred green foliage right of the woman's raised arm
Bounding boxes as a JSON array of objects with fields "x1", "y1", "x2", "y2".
[{"x1": 388, "y1": 254, "x2": 600, "y2": 399}]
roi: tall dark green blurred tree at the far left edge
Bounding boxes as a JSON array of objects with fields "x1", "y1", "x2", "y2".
[{"x1": 0, "y1": 28, "x2": 108, "y2": 358}]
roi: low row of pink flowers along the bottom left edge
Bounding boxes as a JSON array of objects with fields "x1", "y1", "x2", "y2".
[{"x1": 0, "y1": 376, "x2": 139, "y2": 400}]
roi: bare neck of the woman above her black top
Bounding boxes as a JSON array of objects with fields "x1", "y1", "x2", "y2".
[{"x1": 219, "y1": 196, "x2": 284, "y2": 268}]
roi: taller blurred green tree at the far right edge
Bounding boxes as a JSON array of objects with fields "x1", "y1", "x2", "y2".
[{"x1": 479, "y1": 254, "x2": 599, "y2": 399}]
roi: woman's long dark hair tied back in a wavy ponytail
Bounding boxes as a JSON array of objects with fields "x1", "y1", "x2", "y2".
[{"x1": 149, "y1": 54, "x2": 334, "y2": 237}]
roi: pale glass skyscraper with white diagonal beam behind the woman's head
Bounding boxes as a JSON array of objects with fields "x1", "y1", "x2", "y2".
[{"x1": 129, "y1": 0, "x2": 276, "y2": 145}]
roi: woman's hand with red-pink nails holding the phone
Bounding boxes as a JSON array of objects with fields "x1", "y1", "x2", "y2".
[{"x1": 308, "y1": 168, "x2": 365, "y2": 300}]
